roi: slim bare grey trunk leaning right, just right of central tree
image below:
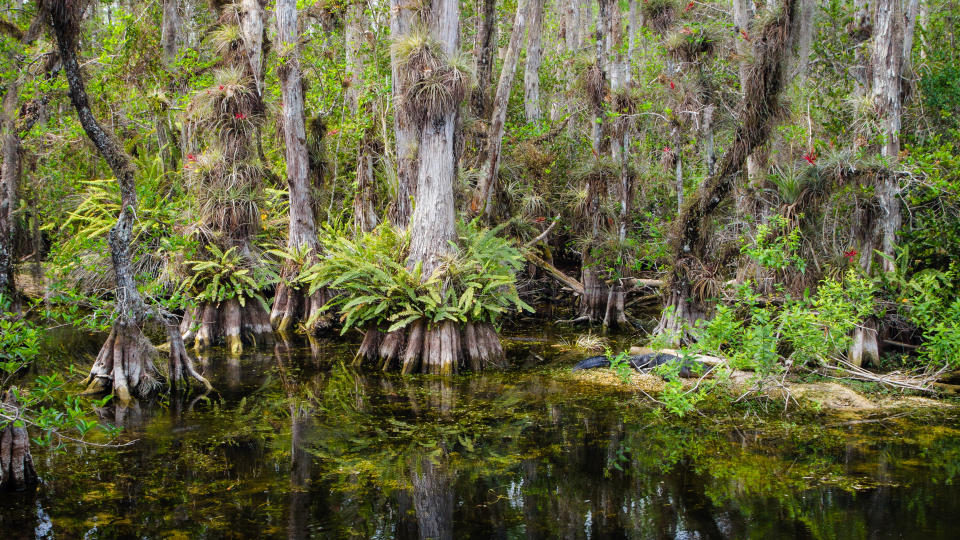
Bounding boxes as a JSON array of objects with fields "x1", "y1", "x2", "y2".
[{"x1": 470, "y1": 0, "x2": 529, "y2": 217}]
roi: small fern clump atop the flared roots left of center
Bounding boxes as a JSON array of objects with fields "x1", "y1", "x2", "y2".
[{"x1": 181, "y1": 244, "x2": 272, "y2": 309}]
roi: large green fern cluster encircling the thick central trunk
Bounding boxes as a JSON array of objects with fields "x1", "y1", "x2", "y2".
[{"x1": 299, "y1": 222, "x2": 533, "y2": 332}]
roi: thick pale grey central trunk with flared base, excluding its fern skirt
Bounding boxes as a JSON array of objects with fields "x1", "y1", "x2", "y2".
[{"x1": 357, "y1": 0, "x2": 503, "y2": 375}]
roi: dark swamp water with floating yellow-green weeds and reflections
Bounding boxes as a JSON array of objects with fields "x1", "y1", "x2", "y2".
[{"x1": 0, "y1": 330, "x2": 960, "y2": 539}]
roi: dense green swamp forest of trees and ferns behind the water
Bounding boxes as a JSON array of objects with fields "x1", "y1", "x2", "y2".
[{"x1": 0, "y1": 0, "x2": 960, "y2": 500}]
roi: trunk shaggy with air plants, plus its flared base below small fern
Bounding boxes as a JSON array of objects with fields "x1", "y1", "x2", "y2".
[{"x1": 180, "y1": 0, "x2": 272, "y2": 354}]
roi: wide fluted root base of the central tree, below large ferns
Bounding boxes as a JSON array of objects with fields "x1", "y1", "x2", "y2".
[{"x1": 356, "y1": 320, "x2": 506, "y2": 375}]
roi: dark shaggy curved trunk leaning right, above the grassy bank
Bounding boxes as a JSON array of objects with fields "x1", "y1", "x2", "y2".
[{"x1": 654, "y1": 0, "x2": 798, "y2": 342}]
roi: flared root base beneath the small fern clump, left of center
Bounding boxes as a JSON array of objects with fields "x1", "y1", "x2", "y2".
[{"x1": 179, "y1": 298, "x2": 273, "y2": 355}]
